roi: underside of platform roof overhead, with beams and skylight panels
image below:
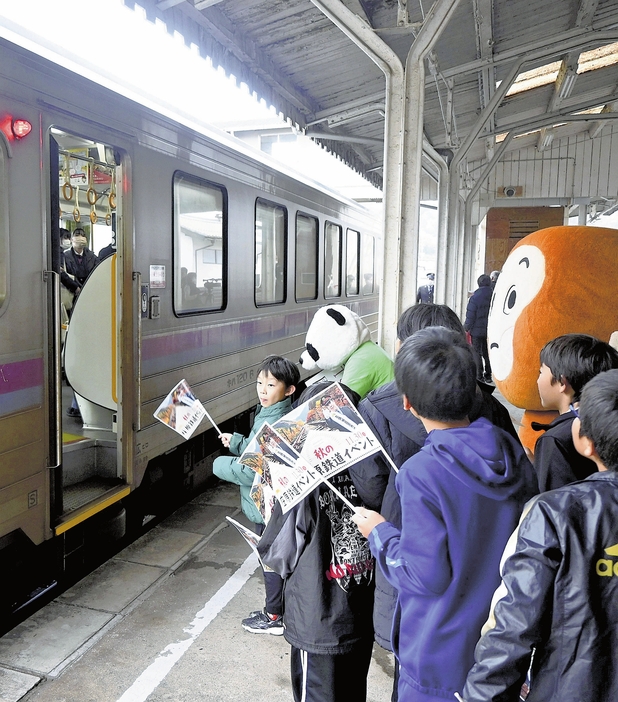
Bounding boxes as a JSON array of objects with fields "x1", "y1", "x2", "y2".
[{"x1": 124, "y1": 0, "x2": 618, "y2": 191}]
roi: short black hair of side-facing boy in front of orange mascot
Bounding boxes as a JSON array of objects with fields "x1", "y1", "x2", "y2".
[{"x1": 541, "y1": 334, "x2": 618, "y2": 402}]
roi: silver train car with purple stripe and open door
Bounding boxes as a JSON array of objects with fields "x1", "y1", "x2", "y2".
[{"x1": 0, "y1": 41, "x2": 382, "y2": 612}]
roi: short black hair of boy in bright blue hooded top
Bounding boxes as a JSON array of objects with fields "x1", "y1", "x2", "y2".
[{"x1": 395, "y1": 327, "x2": 476, "y2": 422}]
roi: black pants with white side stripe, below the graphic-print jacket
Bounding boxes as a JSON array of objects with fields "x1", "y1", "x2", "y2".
[{"x1": 290, "y1": 639, "x2": 373, "y2": 702}]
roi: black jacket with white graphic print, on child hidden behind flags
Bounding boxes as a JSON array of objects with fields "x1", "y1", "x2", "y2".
[{"x1": 258, "y1": 471, "x2": 375, "y2": 655}]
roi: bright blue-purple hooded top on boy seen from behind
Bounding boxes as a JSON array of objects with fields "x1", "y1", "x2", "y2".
[{"x1": 369, "y1": 418, "x2": 537, "y2": 702}]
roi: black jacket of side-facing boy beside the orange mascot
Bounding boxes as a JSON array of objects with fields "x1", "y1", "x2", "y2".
[{"x1": 531, "y1": 412, "x2": 597, "y2": 492}]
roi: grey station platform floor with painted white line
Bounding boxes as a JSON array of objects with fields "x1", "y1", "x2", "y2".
[{"x1": 0, "y1": 483, "x2": 393, "y2": 702}]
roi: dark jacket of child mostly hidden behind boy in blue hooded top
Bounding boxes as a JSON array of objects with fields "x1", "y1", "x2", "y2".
[{"x1": 350, "y1": 382, "x2": 519, "y2": 651}]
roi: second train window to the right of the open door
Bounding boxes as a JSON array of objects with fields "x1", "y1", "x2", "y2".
[{"x1": 255, "y1": 199, "x2": 287, "y2": 306}]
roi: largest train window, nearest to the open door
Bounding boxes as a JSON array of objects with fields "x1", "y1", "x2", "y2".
[{"x1": 174, "y1": 173, "x2": 227, "y2": 314}]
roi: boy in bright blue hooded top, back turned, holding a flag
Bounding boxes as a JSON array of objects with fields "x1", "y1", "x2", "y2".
[{"x1": 354, "y1": 327, "x2": 538, "y2": 702}]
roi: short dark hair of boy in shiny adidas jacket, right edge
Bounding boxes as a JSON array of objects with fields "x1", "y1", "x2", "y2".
[{"x1": 578, "y1": 370, "x2": 618, "y2": 471}]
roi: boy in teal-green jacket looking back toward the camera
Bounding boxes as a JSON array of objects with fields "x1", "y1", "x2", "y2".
[{"x1": 212, "y1": 356, "x2": 300, "y2": 636}]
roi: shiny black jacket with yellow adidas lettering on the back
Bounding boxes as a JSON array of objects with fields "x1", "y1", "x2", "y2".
[{"x1": 463, "y1": 472, "x2": 618, "y2": 702}]
